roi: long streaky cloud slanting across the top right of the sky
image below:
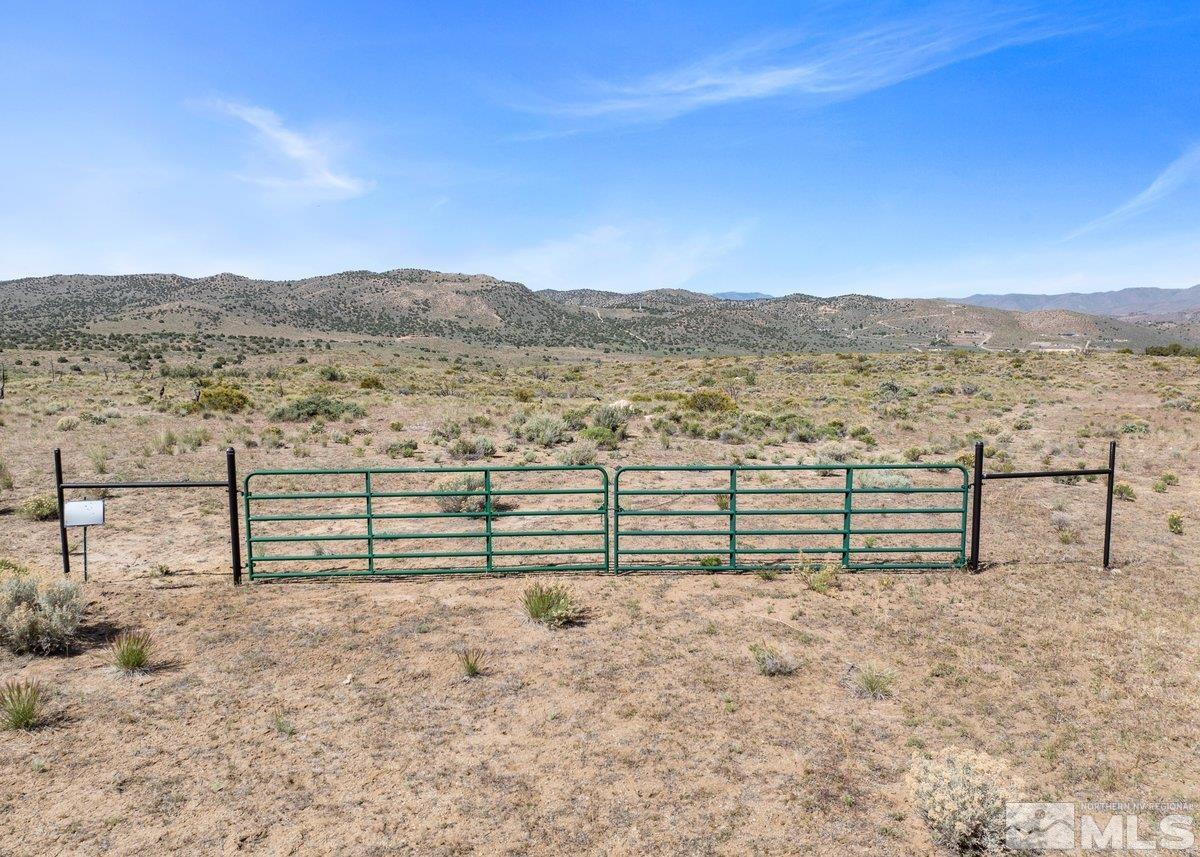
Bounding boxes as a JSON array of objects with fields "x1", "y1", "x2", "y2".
[{"x1": 546, "y1": 5, "x2": 1082, "y2": 121}]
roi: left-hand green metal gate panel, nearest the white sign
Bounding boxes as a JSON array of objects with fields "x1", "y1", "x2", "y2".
[{"x1": 244, "y1": 466, "x2": 610, "y2": 580}]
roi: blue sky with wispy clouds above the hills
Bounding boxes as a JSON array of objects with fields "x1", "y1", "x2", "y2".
[{"x1": 0, "y1": 0, "x2": 1200, "y2": 296}]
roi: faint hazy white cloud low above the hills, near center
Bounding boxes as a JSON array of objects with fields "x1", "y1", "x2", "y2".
[{"x1": 476, "y1": 223, "x2": 750, "y2": 292}]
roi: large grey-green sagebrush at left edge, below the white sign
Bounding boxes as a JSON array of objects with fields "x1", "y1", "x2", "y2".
[{"x1": 0, "y1": 575, "x2": 84, "y2": 654}]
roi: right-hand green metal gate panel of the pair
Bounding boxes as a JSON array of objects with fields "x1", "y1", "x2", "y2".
[{"x1": 613, "y1": 463, "x2": 967, "y2": 571}]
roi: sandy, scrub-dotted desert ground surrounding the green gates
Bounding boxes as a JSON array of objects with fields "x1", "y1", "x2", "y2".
[{"x1": 0, "y1": 337, "x2": 1200, "y2": 855}]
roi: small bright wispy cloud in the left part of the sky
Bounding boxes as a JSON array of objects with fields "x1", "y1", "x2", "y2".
[{"x1": 205, "y1": 100, "x2": 372, "y2": 199}]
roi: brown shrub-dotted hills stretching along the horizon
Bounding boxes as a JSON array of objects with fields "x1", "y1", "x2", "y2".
[{"x1": 0, "y1": 269, "x2": 1200, "y2": 354}]
